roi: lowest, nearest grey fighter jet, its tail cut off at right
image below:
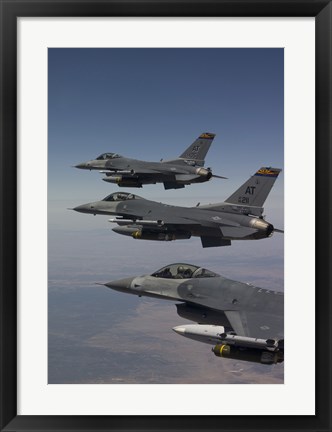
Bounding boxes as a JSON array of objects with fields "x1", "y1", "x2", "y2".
[{"x1": 104, "y1": 263, "x2": 284, "y2": 364}]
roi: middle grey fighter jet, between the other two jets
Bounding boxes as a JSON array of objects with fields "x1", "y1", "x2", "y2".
[{"x1": 73, "y1": 167, "x2": 283, "y2": 248}]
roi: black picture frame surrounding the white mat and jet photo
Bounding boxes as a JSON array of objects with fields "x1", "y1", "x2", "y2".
[{"x1": 0, "y1": 0, "x2": 332, "y2": 432}]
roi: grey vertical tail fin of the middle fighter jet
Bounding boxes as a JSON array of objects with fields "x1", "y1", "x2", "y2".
[{"x1": 225, "y1": 167, "x2": 282, "y2": 207}]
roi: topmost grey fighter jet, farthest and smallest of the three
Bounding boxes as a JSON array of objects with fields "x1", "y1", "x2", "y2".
[{"x1": 75, "y1": 132, "x2": 226, "y2": 189}]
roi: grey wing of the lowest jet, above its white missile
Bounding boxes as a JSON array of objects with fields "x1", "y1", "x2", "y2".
[{"x1": 225, "y1": 310, "x2": 284, "y2": 339}]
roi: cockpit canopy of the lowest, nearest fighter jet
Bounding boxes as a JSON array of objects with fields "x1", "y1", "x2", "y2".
[{"x1": 151, "y1": 263, "x2": 220, "y2": 279}]
